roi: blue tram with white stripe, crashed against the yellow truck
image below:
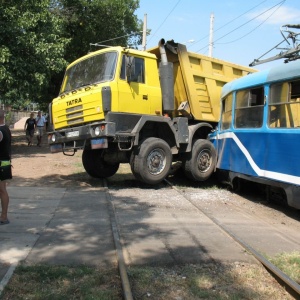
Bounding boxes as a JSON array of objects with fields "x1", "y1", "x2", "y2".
[{"x1": 209, "y1": 60, "x2": 300, "y2": 209}]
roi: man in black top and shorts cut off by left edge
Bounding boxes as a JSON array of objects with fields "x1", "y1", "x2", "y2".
[{"x1": 0, "y1": 109, "x2": 12, "y2": 225}]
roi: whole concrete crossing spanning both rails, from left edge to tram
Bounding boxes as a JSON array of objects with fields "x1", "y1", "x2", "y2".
[{"x1": 0, "y1": 186, "x2": 299, "y2": 292}]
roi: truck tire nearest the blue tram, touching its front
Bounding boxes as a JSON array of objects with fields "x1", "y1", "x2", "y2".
[{"x1": 182, "y1": 140, "x2": 216, "y2": 181}]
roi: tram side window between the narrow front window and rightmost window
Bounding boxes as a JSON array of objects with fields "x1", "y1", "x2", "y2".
[{"x1": 234, "y1": 87, "x2": 264, "y2": 128}]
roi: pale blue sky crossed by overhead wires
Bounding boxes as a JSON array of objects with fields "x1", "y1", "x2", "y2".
[{"x1": 136, "y1": 0, "x2": 300, "y2": 70}]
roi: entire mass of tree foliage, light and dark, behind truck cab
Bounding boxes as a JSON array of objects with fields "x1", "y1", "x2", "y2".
[{"x1": 0, "y1": 0, "x2": 142, "y2": 108}]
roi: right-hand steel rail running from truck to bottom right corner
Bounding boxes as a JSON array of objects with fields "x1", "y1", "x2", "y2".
[{"x1": 165, "y1": 179, "x2": 300, "y2": 299}]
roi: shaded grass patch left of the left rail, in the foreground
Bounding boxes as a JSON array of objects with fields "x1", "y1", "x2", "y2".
[{"x1": 0, "y1": 265, "x2": 122, "y2": 300}]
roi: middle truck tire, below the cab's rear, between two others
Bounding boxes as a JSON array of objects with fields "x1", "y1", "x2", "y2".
[{"x1": 130, "y1": 137, "x2": 172, "y2": 184}]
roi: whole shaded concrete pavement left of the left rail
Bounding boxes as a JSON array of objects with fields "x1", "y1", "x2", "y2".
[{"x1": 0, "y1": 186, "x2": 116, "y2": 291}]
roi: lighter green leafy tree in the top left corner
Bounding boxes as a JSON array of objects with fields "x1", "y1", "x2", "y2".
[{"x1": 0, "y1": 0, "x2": 69, "y2": 108}]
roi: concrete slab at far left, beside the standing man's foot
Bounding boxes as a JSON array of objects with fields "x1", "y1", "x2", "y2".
[{"x1": 0, "y1": 186, "x2": 65, "y2": 264}]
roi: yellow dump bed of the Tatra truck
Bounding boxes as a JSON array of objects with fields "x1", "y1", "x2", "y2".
[{"x1": 147, "y1": 41, "x2": 256, "y2": 122}]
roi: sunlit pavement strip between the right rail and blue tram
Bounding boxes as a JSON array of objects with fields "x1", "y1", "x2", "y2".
[{"x1": 189, "y1": 192, "x2": 300, "y2": 256}]
